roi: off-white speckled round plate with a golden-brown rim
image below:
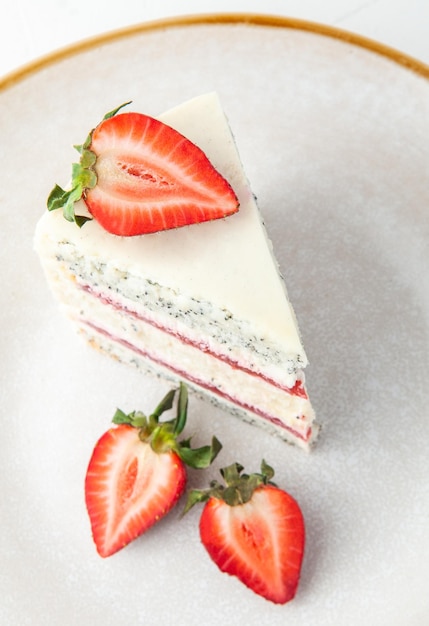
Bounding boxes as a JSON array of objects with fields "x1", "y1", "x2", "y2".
[{"x1": 0, "y1": 15, "x2": 429, "y2": 626}]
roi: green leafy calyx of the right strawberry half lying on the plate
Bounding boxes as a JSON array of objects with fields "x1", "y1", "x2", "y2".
[{"x1": 183, "y1": 460, "x2": 276, "y2": 514}]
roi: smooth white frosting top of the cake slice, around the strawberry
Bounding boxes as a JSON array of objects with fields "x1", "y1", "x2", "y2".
[{"x1": 36, "y1": 93, "x2": 307, "y2": 358}]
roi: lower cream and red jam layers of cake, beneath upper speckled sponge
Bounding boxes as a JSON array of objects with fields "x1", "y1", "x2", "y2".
[{"x1": 37, "y1": 256, "x2": 318, "y2": 449}]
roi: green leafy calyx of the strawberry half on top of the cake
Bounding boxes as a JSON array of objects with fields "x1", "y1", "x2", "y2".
[{"x1": 47, "y1": 101, "x2": 131, "y2": 227}]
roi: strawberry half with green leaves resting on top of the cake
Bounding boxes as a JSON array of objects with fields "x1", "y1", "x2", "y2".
[{"x1": 47, "y1": 103, "x2": 239, "y2": 236}]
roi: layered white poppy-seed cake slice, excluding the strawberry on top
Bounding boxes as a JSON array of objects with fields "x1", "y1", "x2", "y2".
[{"x1": 35, "y1": 93, "x2": 318, "y2": 449}]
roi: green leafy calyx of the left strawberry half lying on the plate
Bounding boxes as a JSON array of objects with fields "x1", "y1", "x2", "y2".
[{"x1": 112, "y1": 382, "x2": 222, "y2": 469}]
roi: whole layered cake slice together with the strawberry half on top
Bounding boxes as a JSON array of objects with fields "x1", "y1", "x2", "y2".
[{"x1": 35, "y1": 93, "x2": 318, "y2": 449}]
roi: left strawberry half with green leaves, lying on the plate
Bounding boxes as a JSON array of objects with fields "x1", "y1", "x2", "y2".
[{"x1": 85, "y1": 384, "x2": 221, "y2": 557}]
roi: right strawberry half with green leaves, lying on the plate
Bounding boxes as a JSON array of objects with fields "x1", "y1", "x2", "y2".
[{"x1": 185, "y1": 461, "x2": 305, "y2": 604}]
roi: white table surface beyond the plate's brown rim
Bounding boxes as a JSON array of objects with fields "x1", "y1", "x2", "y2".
[{"x1": 0, "y1": 0, "x2": 429, "y2": 76}]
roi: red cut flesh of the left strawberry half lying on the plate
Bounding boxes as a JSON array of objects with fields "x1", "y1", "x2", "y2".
[{"x1": 85, "y1": 424, "x2": 186, "y2": 557}]
